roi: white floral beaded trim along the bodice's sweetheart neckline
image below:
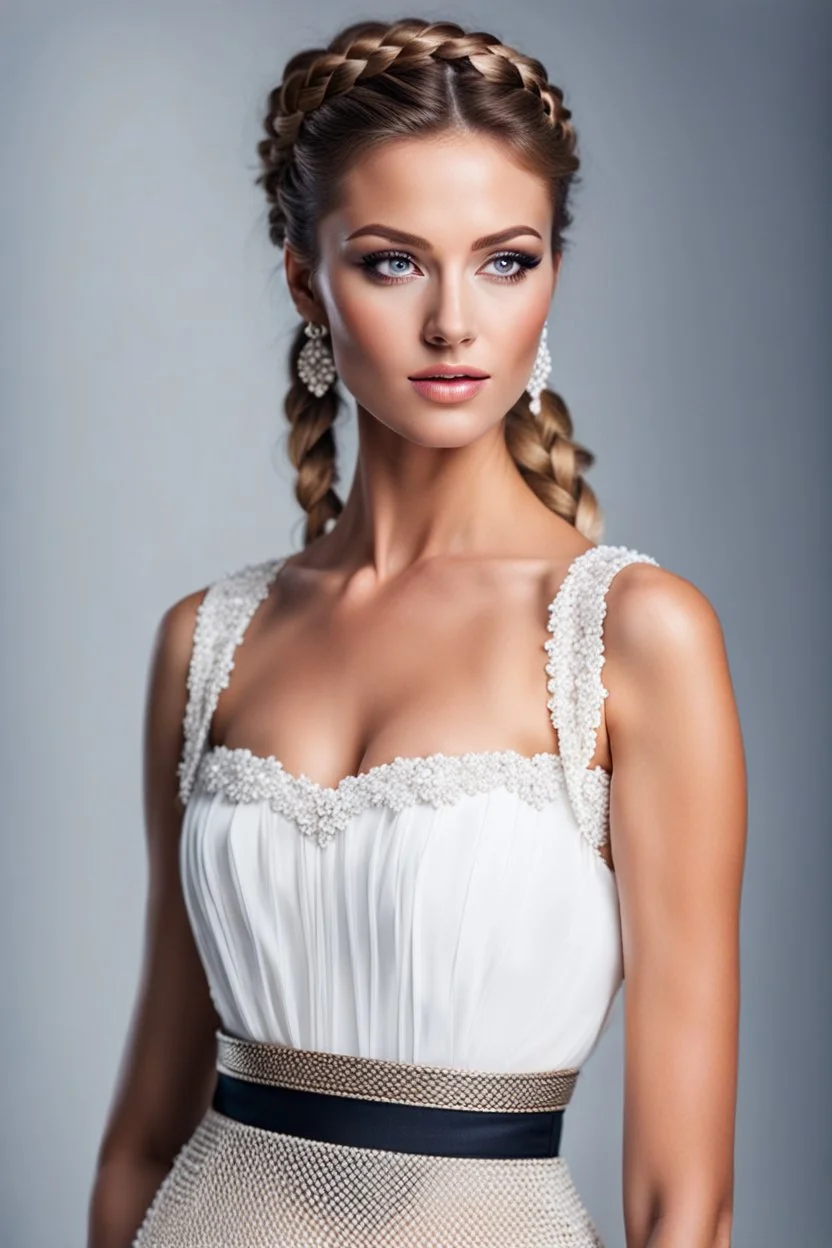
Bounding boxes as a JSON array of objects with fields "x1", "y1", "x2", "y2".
[{"x1": 198, "y1": 745, "x2": 578, "y2": 846}]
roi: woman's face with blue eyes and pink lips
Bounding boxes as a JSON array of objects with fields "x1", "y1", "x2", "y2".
[{"x1": 286, "y1": 134, "x2": 559, "y2": 447}]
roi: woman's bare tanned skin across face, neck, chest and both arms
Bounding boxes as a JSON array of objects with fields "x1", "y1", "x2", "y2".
[{"x1": 89, "y1": 134, "x2": 746, "y2": 1248}]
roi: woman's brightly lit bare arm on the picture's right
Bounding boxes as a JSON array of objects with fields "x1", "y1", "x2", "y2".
[{"x1": 604, "y1": 564, "x2": 747, "y2": 1248}]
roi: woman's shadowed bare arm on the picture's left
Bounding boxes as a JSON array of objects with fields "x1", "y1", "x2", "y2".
[{"x1": 87, "y1": 590, "x2": 220, "y2": 1248}]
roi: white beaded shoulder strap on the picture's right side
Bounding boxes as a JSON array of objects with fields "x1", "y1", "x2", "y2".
[{"x1": 545, "y1": 545, "x2": 659, "y2": 846}]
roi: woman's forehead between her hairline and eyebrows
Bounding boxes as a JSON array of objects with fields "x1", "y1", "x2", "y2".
[{"x1": 321, "y1": 131, "x2": 551, "y2": 246}]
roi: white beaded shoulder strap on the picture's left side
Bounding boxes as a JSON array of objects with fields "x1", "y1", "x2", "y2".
[{"x1": 177, "y1": 558, "x2": 286, "y2": 805}]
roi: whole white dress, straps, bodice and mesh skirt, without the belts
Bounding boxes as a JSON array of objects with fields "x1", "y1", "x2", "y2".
[{"x1": 135, "y1": 545, "x2": 657, "y2": 1248}]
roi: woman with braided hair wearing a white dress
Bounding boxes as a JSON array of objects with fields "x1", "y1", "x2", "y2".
[{"x1": 90, "y1": 19, "x2": 745, "y2": 1248}]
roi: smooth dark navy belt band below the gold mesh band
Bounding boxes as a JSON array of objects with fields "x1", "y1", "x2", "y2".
[{"x1": 211, "y1": 1071, "x2": 565, "y2": 1157}]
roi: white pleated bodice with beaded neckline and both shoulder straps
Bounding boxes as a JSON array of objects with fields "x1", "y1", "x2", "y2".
[{"x1": 178, "y1": 545, "x2": 656, "y2": 1071}]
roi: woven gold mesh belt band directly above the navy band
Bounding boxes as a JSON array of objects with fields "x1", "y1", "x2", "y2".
[{"x1": 217, "y1": 1030, "x2": 579, "y2": 1113}]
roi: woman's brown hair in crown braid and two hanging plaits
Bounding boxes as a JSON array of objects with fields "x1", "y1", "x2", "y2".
[{"x1": 257, "y1": 17, "x2": 602, "y2": 545}]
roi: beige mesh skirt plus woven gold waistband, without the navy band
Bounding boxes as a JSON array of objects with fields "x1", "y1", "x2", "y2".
[{"x1": 133, "y1": 1033, "x2": 602, "y2": 1248}]
